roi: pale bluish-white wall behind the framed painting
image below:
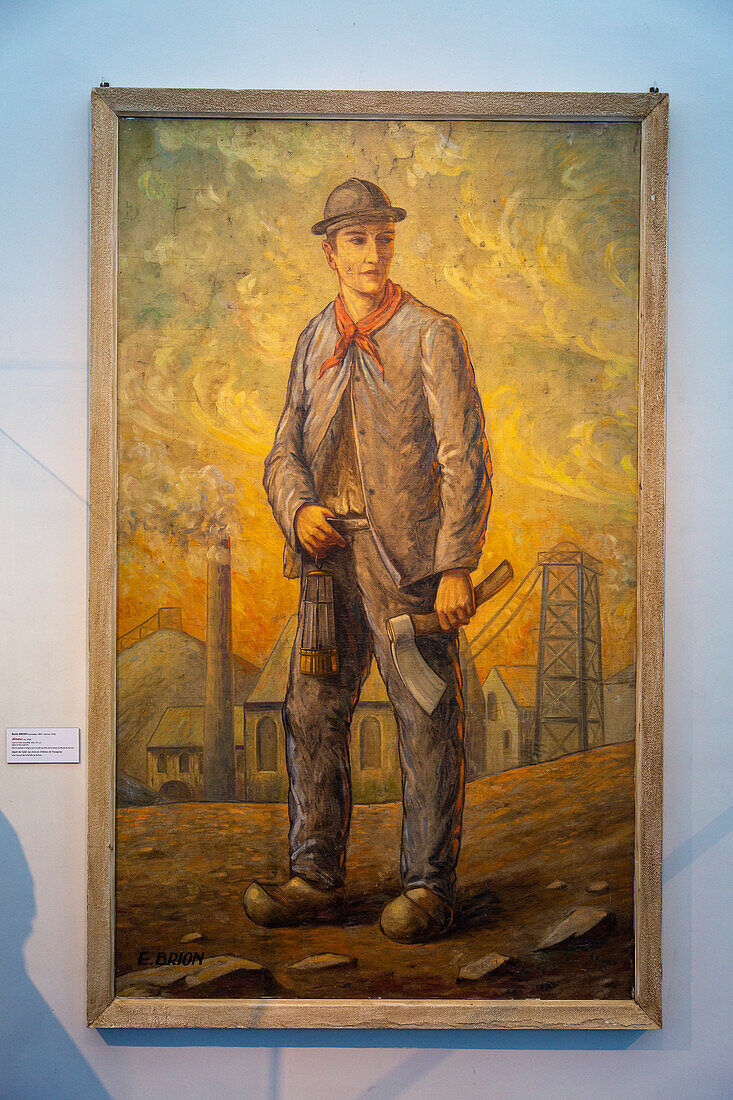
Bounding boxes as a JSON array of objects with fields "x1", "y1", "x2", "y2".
[{"x1": 0, "y1": 0, "x2": 733, "y2": 1100}]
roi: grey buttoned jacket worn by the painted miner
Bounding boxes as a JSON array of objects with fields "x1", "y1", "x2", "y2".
[{"x1": 264, "y1": 298, "x2": 491, "y2": 586}]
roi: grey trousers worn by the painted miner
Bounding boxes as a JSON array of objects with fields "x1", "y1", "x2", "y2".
[{"x1": 283, "y1": 530, "x2": 464, "y2": 901}]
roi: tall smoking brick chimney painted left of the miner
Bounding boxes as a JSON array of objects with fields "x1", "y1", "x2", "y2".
[{"x1": 204, "y1": 538, "x2": 236, "y2": 802}]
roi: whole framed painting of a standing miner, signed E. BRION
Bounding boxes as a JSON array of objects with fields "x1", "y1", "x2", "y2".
[{"x1": 88, "y1": 87, "x2": 668, "y2": 1029}]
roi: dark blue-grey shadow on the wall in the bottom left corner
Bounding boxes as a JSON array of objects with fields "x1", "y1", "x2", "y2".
[{"x1": 0, "y1": 813, "x2": 109, "y2": 1100}]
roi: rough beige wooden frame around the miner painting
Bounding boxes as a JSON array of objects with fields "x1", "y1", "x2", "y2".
[{"x1": 87, "y1": 87, "x2": 668, "y2": 1030}]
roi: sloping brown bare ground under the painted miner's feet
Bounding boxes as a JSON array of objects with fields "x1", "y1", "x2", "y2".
[{"x1": 117, "y1": 744, "x2": 634, "y2": 999}]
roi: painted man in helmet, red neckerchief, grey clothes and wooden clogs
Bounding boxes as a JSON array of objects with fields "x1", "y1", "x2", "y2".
[{"x1": 244, "y1": 179, "x2": 491, "y2": 943}]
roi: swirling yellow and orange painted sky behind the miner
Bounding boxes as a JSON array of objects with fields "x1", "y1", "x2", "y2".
[{"x1": 119, "y1": 119, "x2": 639, "y2": 672}]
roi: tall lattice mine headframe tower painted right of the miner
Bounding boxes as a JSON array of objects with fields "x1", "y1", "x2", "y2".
[{"x1": 534, "y1": 542, "x2": 604, "y2": 761}]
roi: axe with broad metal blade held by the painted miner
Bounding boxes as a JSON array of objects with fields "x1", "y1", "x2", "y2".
[{"x1": 387, "y1": 561, "x2": 514, "y2": 714}]
